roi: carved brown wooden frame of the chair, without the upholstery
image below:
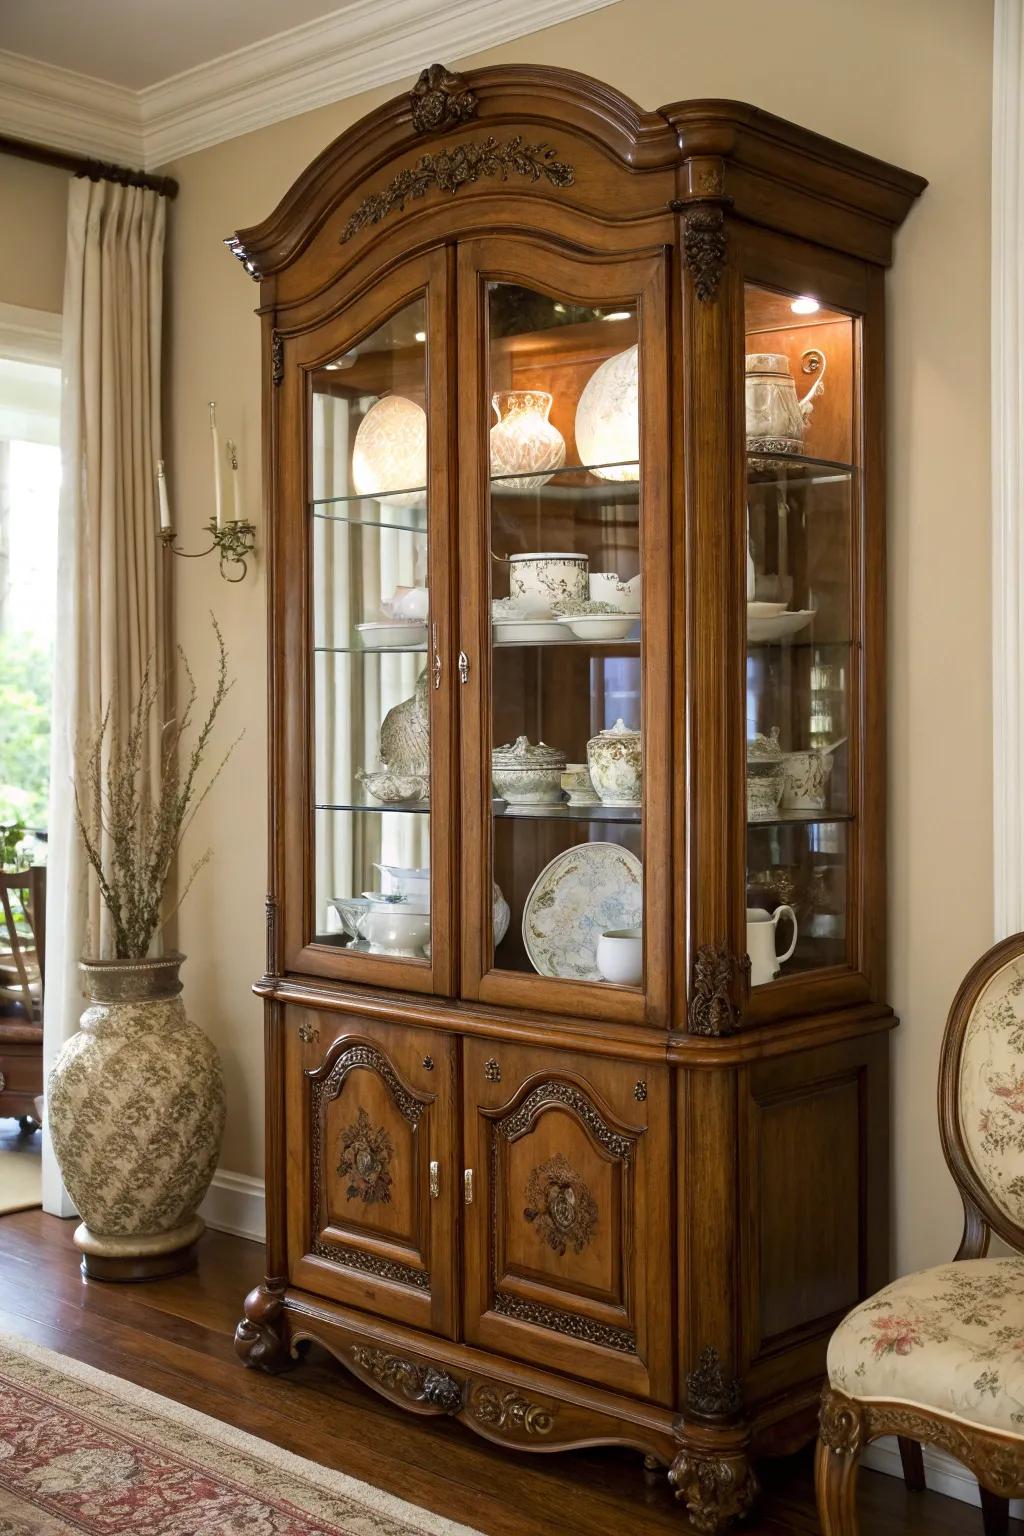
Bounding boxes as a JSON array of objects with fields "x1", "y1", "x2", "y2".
[{"x1": 815, "y1": 932, "x2": 1024, "y2": 1536}]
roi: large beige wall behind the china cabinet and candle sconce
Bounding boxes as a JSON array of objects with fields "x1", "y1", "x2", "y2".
[{"x1": 160, "y1": 0, "x2": 992, "y2": 1267}]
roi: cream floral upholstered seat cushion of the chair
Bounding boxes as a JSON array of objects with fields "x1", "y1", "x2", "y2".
[{"x1": 829, "y1": 1258, "x2": 1024, "y2": 1436}]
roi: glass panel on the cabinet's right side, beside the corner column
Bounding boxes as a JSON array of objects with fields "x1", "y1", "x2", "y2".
[{"x1": 745, "y1": 284, "x2": 858, "y2": 986}]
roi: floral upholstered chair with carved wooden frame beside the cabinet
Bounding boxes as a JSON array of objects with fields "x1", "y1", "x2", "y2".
[{"x1": 817, "y1": 934, "x2": 1024, "y2": 1536}]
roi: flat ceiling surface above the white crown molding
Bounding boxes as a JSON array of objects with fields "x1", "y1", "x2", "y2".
[{"x1": 0, "y1": 0, "x2": 344, "y2": 91}]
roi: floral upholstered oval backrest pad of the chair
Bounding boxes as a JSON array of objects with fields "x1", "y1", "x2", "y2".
[{"x1": 960, "y1": 960, "x2": 1024, "y2": 1226}]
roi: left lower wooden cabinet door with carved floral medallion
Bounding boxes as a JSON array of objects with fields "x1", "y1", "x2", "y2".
[{"x1": 286, "y1": 1009, "x2": 459, "y2": 1338}]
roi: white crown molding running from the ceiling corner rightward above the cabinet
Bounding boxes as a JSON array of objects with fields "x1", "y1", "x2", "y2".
[{"x1": 138, "y1": 0, "x2": 617, "y2": 170}]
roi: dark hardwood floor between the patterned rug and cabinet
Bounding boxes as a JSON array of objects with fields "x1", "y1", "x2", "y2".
[{"x1": 0, "y1": 1210, "x2": 1007, "y2": 1536}]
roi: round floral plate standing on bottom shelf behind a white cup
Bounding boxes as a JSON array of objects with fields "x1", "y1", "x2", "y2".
[{"x1": 522, "y1": 843, "x2": 643, "y2": 982}]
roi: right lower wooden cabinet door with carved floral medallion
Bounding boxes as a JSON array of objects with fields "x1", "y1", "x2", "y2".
[{"x1": 462, "y1": 1040, "x2": 672, "y2": 1402}]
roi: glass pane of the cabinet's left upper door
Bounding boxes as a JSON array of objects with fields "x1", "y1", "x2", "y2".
[{"x1": 310, "y1": 300, "x2": 431, "y2": 965}]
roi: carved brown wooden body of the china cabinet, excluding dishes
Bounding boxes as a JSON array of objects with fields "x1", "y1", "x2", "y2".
[{"x1": 238, "y1": 66, "x2": 924, "y2": 1533}]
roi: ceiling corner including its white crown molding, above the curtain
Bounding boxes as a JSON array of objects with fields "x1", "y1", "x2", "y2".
[{"x1": 0, "y1": 0, "x2": 619, "y2": 170}]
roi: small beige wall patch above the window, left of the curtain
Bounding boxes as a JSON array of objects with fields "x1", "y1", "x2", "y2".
[{"x1": 0, "y1": 155, "x2": 68, "y2": 315}]
